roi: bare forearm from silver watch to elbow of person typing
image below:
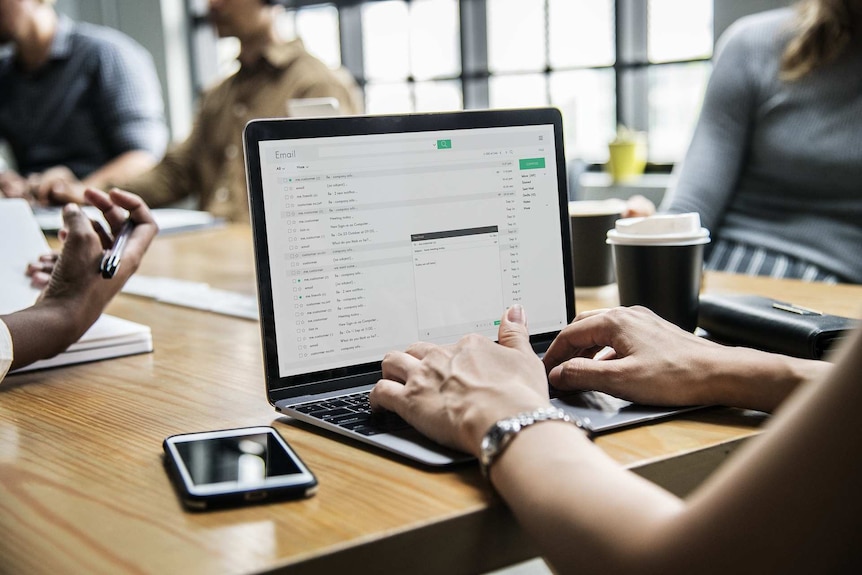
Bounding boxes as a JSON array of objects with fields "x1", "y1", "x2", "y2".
[{"x1": 491, "y1": 422, "x2": 684, "y2": 573}]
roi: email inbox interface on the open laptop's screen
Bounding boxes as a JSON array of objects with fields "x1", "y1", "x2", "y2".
[{"x1": 253, "y1": 124, "x2": 568, "y2": 388}]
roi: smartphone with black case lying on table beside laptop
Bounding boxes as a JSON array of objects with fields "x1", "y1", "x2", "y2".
[{"x1": 163, "y1": 426, "x2": 317, "y2": 511}]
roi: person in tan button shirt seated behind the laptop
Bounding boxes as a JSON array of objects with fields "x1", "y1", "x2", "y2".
[{"x1": 36, "y1": 0, "x2": 362, "y2": 222}]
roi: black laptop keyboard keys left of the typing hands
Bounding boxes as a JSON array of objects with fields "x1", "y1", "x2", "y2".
[{"x1": 292, "y1": 391, "x2": 410, "y2": 435}]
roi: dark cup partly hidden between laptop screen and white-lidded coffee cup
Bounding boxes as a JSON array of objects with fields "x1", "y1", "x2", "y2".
[{"x1": 569, "y1": 199, "x2": 626, "y2": 288}]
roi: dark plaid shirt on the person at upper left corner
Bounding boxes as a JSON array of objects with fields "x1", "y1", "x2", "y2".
[{"x1": 0, "y1": 15, "x2": 168, "y2": 178}]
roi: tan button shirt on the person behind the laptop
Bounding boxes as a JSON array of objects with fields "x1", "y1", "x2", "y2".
[{"x1": 120, "y1": 40, "x2": 362, "y2": 222}]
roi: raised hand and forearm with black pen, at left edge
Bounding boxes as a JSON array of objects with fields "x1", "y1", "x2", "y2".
[{"x1": 0, "y1": 188, "x2": 158, "y2": 382}]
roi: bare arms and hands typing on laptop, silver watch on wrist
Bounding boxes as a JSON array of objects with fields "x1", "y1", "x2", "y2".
[{"x1": 370, "y1": 306, "x2": 862, "y2": 573}]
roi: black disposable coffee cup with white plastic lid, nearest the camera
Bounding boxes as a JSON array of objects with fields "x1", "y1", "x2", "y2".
[{"x1": 607, "y1": 213, "x2": 709, "y2": 331}]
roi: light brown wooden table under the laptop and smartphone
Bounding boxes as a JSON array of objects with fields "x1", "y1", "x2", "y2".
[{"x1": 0, "y1": 226, "x2": 862, "y2": 573}]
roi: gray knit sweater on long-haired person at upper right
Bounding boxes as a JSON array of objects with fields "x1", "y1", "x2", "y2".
[{"x1": 663, "y1": 9, "x2": 862, "y2": 283}]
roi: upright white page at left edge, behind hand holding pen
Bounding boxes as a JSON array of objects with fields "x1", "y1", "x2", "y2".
[{"x1": 0, "y1": 198, "x2": 51, "y2": 314}]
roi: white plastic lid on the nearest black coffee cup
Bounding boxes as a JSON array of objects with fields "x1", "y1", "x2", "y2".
[{"x1": 608, "y1": 212, "x2": 709, "y2": 246}]
